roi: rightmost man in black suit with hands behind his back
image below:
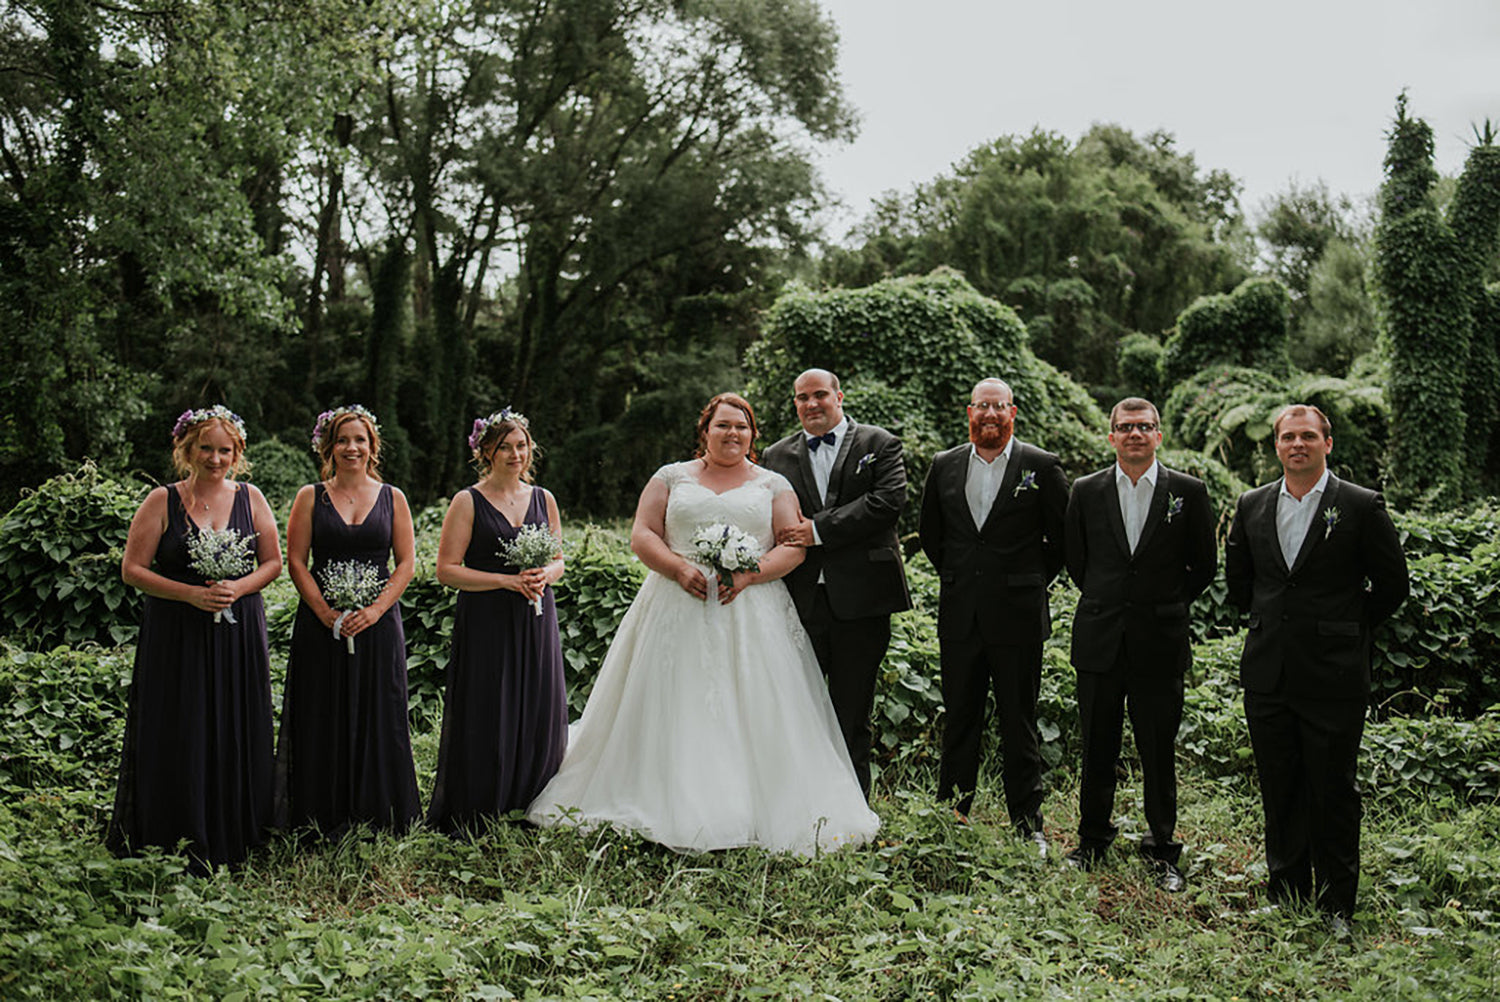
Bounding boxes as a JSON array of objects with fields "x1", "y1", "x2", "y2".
[{"x1": 1226, "y1": 404, "x2": 1410, "y2": 933}]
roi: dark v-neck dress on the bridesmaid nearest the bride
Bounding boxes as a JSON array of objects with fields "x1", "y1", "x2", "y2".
[{"x1": 428, "y1": 488, "x2": 567, "y2": 834}]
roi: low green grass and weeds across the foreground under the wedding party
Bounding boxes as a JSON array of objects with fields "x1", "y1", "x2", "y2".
[{"x1": 0, "y1": 732, "x2": 1500, "y2": 999}]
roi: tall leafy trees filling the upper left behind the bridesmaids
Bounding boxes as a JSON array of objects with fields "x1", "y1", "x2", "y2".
[{"x1": 0, "y1": 0, "x2": 854, "y2": 513}]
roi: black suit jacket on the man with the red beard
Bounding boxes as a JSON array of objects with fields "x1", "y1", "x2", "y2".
[{"x1": 920, "y1": 440, "x2": 1068, "y2": 645}]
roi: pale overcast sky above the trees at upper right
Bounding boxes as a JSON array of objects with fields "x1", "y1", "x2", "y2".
[{"x1": 819, "y1": 0, "x2": 1500, "y2": 239}]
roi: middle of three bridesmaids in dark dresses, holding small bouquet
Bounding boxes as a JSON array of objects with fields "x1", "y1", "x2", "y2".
[{"x1": 276, "y1": 404, "x2": 422, "y2": 839}]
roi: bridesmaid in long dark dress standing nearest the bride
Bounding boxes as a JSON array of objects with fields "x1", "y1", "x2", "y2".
[{"x1": 428, "y1": 408, "x2": 567, "y2": 834}]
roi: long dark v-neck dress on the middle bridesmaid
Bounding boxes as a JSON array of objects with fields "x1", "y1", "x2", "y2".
[{"x1": 276, "y1": 483, "x2": 422, "y2": 839}]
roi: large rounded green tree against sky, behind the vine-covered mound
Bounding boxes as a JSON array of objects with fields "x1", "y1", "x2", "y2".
[{"x1": 824, "y1": 125, "x2": 1245, "y2": 396}]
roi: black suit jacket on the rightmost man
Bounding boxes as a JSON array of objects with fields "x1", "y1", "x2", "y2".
[{"x1": 1224, "y1": 476, "x2": 1410, "y2": 699}]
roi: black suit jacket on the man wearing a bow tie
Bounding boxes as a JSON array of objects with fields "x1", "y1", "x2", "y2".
[{"x1": 762, "y1": 420, "x2": 912, "y2": 620}]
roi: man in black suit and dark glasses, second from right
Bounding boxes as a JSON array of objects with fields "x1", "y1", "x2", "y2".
[{"x1": 1067, "y1": 396, "x2": 1217, "y2": 891}]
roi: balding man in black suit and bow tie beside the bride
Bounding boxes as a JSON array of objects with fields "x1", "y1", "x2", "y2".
[{"x1": 765, "y1": 369, "x2": 911, "y2": 798}]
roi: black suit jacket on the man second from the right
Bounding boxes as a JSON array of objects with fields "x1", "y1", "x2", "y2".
[{"x1": 1065, "y1": 464, "x2": 1218, "y2": 675}]
